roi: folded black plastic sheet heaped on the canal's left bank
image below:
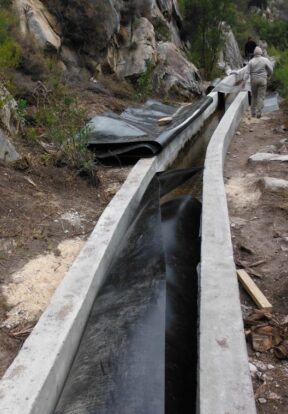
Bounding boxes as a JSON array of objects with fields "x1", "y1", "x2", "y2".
[{"x1": 89, "y1": 96, "x2": 213, "y2": 158}]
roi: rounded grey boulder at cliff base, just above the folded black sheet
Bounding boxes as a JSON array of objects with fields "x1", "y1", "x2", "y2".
[{"x1": 153, "y1": 42, "x2": 202, "y2": 99}]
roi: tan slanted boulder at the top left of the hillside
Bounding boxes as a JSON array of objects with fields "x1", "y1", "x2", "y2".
[{"x1": 14, "y1": 0, "x2": 61, "y2": 51}]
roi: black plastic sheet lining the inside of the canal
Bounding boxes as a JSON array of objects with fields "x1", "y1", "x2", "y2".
[{"x1": 55, "y1": 168, "x2": 201, "y2": 414}]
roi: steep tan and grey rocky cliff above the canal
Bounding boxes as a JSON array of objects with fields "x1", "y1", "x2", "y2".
[{"x1": 14, "y1": 0, "x2": 201, "y2": 99}]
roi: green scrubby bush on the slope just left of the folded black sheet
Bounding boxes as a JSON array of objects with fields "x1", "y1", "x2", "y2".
[{"x1": 22, "y1": 60, "x2": 97, "y2": 184}]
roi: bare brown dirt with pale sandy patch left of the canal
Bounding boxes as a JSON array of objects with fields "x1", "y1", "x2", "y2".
[{"x1": 0, "y1": 160, "x2": 129, "y2": 377}]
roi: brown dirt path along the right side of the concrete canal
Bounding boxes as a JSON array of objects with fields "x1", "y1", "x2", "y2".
[{"x1": 225, "y1": 104, "x2": 288, "y2": 414}]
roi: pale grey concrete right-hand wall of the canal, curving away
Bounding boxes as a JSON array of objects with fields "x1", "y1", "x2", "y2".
[{"x1": 198, "y1": 92, "x2": 256, "y2": 414}]
